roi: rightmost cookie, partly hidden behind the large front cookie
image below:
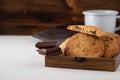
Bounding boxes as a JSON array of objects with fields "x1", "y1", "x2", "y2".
[{"x1": 103, "y1": 32, "x2": 120, "y2": 58}]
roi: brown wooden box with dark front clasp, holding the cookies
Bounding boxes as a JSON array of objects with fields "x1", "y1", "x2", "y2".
[{"x1": 45, "y1": 54, "x2": 120, "y2": 71}]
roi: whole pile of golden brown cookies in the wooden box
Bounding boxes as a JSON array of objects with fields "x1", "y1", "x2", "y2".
[{"x1": 60, "y1": 25, "x2": 120, "y2": 58}]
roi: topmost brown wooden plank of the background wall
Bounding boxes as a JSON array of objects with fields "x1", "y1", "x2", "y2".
[{"x1": 0, "y1": 0, "x2": 120, "y2": 13}]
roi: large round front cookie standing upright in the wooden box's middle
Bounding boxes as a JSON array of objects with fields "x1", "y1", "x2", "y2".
[{"x1": 65, "y1": 33, "x2": 104, "y2": 58}]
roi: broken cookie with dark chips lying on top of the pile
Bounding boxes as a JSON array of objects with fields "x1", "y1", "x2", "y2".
[{"x1": 67, "y1": 25, "x2": 105, "y2": 37}]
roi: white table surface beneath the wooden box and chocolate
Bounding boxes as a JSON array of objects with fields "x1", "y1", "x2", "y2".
[{"x1": 0, "y1": 35, "x2": 120, "y2": 80}]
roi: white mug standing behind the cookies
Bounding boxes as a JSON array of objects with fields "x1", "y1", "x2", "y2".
[{"x1": 83, "y1": 10, "x2": 120, "y2": 32}]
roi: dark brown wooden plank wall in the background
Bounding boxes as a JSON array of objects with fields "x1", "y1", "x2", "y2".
[{"x1": 0, "y1": 0, "x2": 120, "y2": 35}]
